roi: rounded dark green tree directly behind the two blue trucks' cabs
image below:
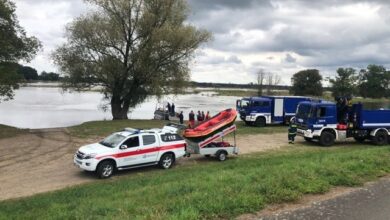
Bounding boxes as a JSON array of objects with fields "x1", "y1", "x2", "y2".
[{"x1": 290, "y1": 69, "x2": 322, "y2": 96}]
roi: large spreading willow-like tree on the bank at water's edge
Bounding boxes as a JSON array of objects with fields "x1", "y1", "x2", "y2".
[{"x1": 54, "y1": 0, "x2": 210, "y2": 119}]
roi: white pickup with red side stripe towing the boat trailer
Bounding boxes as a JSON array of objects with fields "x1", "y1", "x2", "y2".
[{"x1": 74, "y1": 128, "x2": 187, "y2": 178}]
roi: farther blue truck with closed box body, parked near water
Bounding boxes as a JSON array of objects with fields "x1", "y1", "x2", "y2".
[{"x1": 236, "y1": 96, "x2": 313, "y2": 127}]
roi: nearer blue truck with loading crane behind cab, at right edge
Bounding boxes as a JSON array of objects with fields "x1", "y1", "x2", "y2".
[{"x1": 295, "y1": 101, "x2": 390, "y2": 146}]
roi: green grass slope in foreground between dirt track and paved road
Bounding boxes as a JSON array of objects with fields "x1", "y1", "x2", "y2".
[{"x1": 0, "y1": 146, "x2": 390, "y2": 219}]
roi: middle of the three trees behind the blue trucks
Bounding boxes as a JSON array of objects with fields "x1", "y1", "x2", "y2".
[{"x1": 329, "y1": 68, "x2": 358, "y2": 97}]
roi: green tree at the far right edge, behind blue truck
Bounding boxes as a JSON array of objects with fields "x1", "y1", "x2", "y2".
[{"x1": 359, "y1": 65, "x2": 390, "y2": 98}]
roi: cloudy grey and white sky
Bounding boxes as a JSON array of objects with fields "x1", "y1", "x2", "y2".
[{"x1": 14, "y1": 0, "x2": 390, "y2": 85}]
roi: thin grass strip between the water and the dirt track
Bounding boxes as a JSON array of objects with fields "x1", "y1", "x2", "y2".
[{"x1": 69, "y1": 120, "x2": 287, "y2": 138}]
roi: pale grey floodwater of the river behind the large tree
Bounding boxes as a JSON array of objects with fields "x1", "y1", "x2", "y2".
[{"x1": 0, "y1": 87, "x2": 239, "y2": 128}]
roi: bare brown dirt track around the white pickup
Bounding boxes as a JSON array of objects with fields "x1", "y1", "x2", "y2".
[{"x1": 0, "y1": 129, "x2": 287, "y2": 200}]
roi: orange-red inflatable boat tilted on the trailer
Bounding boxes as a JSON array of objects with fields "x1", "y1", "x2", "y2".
[{"x1": 183, "y1": 109, "x2": 237, "y2": 142}]
